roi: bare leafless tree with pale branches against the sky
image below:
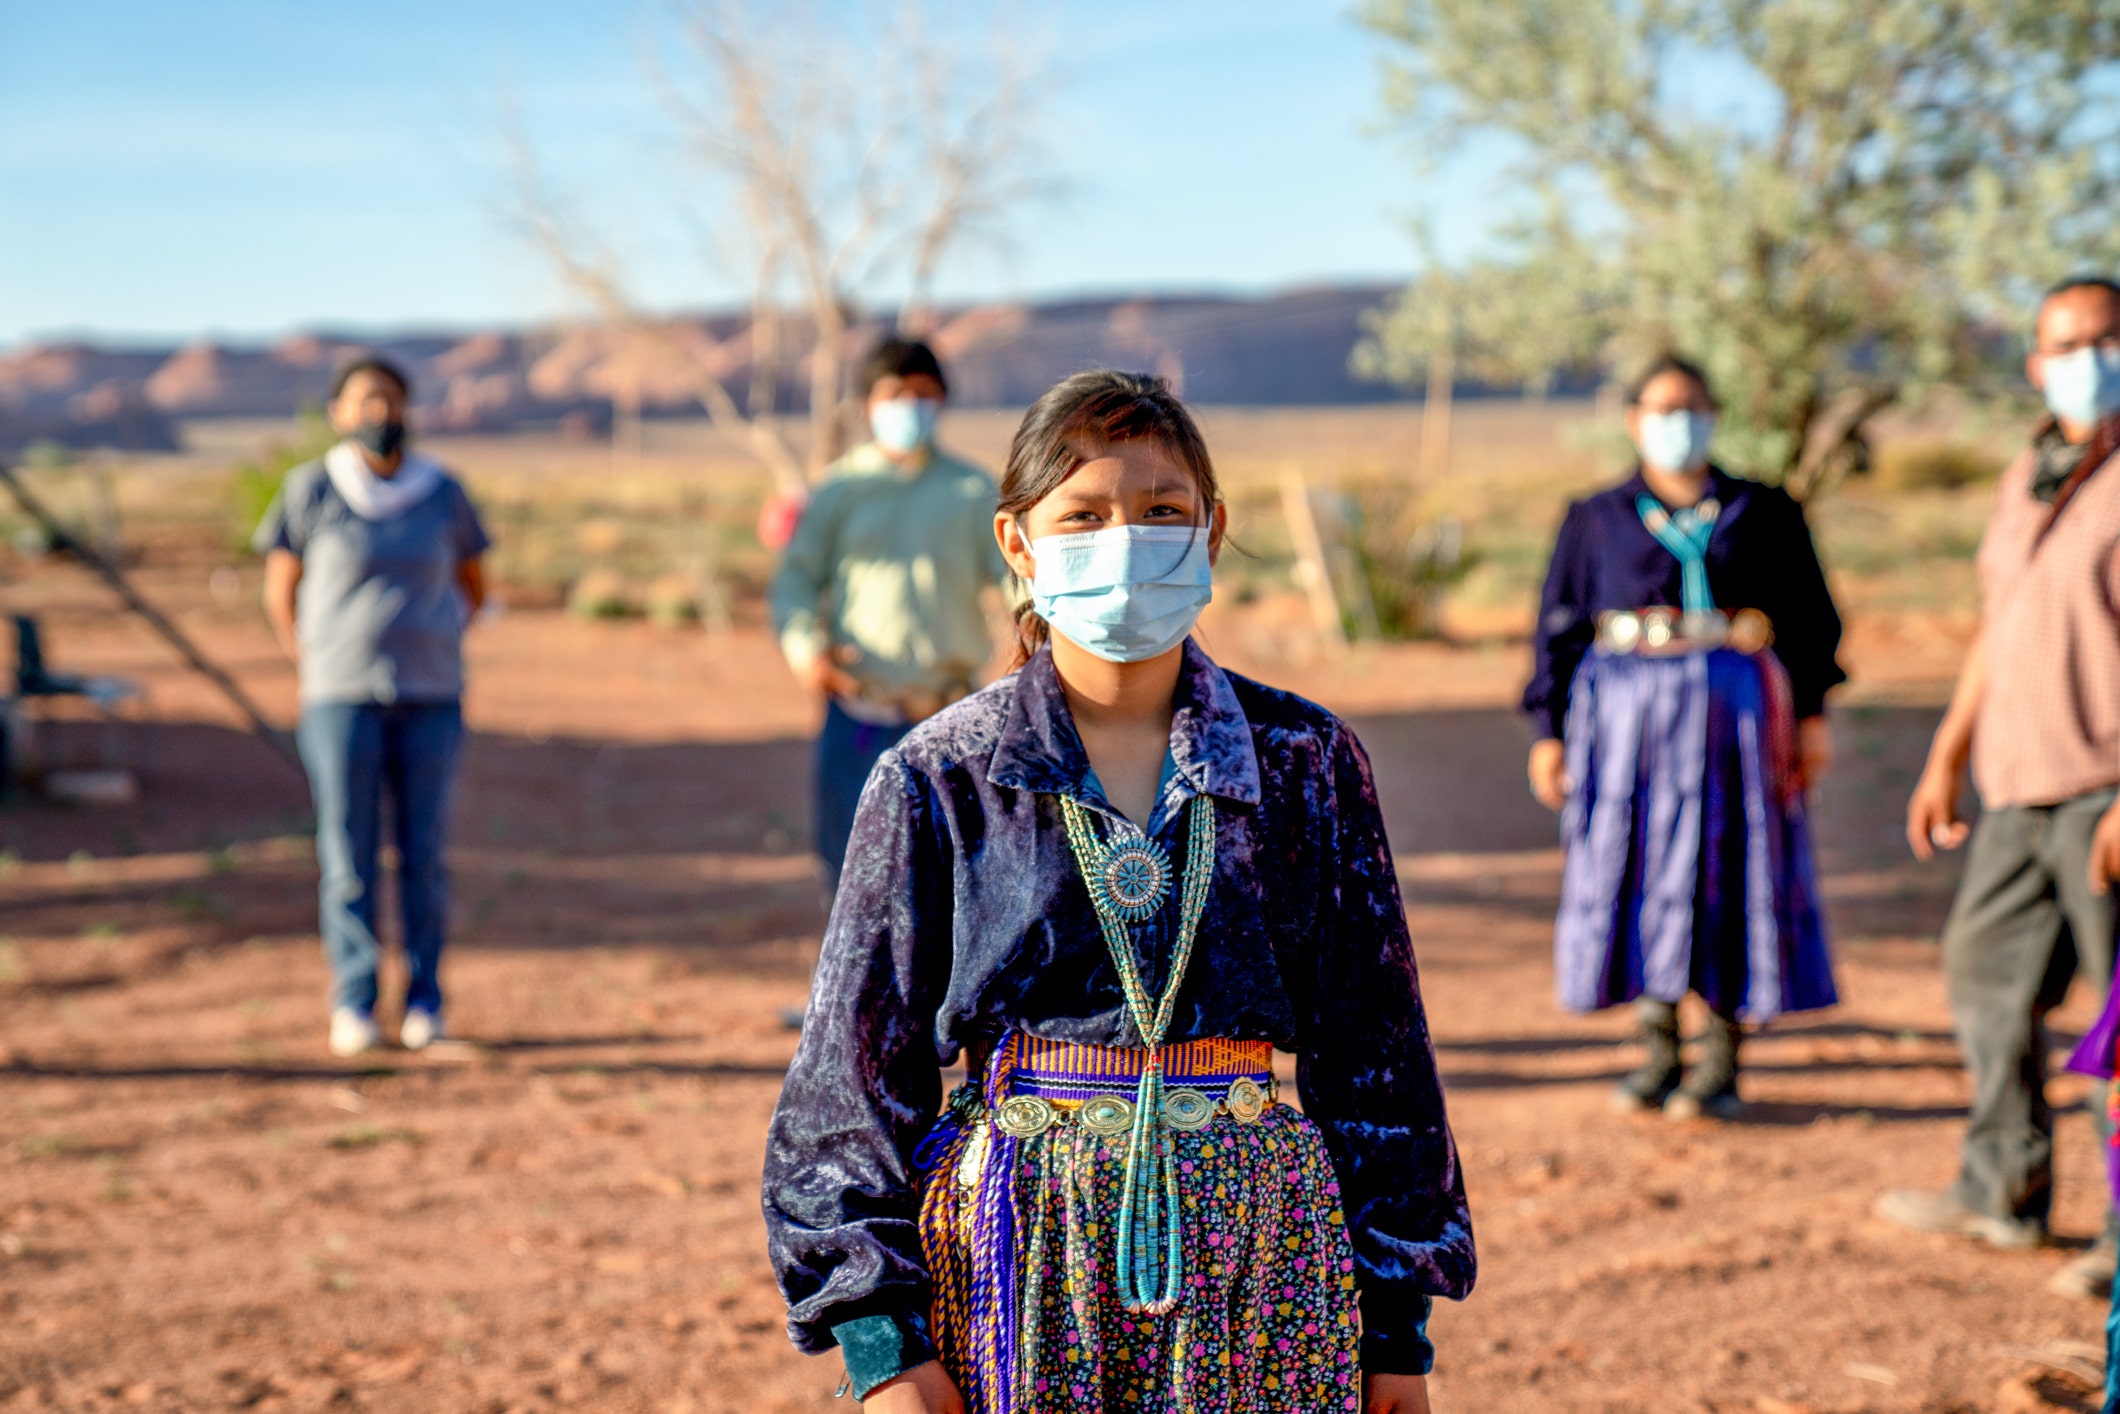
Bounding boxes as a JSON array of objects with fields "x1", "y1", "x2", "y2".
[{"x1": 511, "y1": 0, "x2": 1045, "y2": 494}]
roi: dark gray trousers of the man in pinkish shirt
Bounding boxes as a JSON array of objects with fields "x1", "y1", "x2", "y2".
[{"x1": 1944, "y1": 789, "x2": 2116, "y2": 1227}]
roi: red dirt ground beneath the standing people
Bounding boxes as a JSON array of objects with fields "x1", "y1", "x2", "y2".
[{"x1": 0, "y1": 546, "x2": 2103, "y2": 1414}]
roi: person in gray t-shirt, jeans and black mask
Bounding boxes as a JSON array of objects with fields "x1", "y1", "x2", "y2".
[{"x1": 252, "y1": 358, "x2": 490, "y2": 1056}]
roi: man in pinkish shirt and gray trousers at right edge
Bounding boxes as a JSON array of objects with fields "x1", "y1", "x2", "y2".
[{"x1": 1876, "y1": 278, "x2": 2120, "y2": 1297}]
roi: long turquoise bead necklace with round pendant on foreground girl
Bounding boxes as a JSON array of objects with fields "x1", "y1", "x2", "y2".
[{"x1": 1060, "y1": 795, "x2": 1215, "y2": 1316}]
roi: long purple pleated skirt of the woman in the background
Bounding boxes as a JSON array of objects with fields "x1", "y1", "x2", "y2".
[{"x1": 1554, "y1": 649, "x2": 1840, "y2": 1022}]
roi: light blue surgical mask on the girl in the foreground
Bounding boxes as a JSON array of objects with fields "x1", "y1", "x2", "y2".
[{"x1": 1030, "y1": 526, "x2": 1215, "y2": 664}]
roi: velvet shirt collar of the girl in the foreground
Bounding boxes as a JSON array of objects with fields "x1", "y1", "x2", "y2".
[{"x1": 986, "y1": 638, "x2": 1259, "y2": 806}]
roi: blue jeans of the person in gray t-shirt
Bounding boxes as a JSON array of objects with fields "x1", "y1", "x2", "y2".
[{"x1": 297, "y1": 700, "x2": 464, "y2": 1015}]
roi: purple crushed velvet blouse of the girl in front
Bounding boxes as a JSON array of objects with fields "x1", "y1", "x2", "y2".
[{"x1": 765, "y1": 642, "x2": 1476, "y2": 1374}]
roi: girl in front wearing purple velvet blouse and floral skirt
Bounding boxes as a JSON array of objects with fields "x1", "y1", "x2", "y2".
[{"x1": 765, "y1": 371, "x2": 1473, "y2": 1414}]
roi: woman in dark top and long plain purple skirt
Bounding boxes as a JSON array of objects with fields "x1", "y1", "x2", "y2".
[{"x1": 1524, "y1": 358, "x2": 1847, "y2": 1119}]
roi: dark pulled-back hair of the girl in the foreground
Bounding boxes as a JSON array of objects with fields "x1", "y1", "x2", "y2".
[{"x1": 994, "y1": 369, "x2": 1221, "y2": 666}]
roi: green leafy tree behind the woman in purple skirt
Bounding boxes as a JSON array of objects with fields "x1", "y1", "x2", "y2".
[{"x1": 1357, "y1": 0, "x2": 2120, "y2": 492}]
